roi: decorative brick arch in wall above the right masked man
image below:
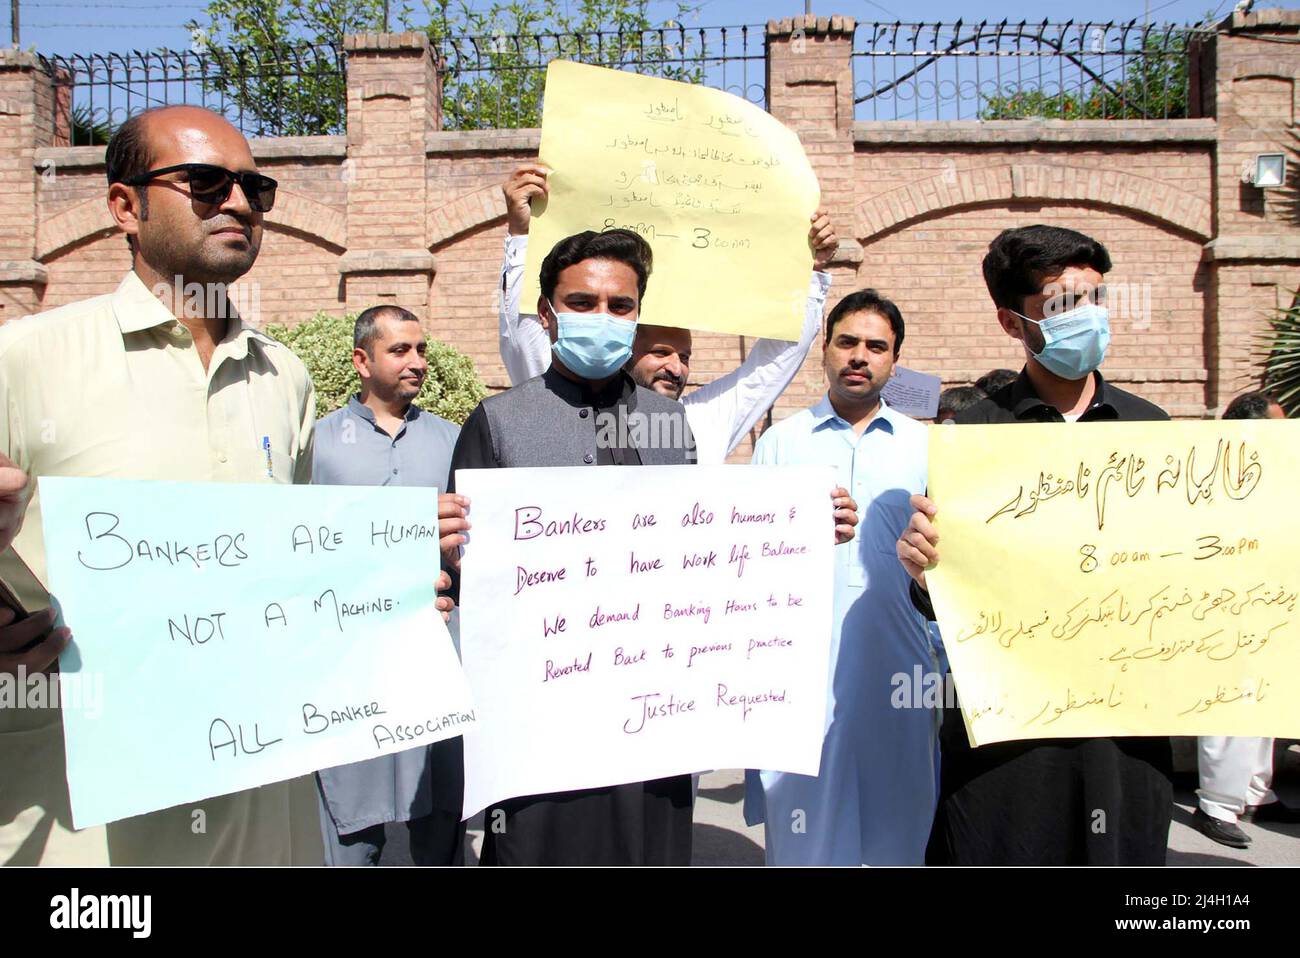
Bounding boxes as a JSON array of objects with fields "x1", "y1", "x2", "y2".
[{"x1": 855, "y1": 162, "x2": 1212, "y2": 243}]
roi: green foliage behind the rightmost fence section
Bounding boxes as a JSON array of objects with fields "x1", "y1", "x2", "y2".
[{"x1": 980, "y1": 31, "x2": 1187, "y2": 120}]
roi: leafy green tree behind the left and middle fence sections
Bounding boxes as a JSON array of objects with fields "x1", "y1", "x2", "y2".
[{"x1": 187, "y1": 0, "x2": 703, "y2": 136}]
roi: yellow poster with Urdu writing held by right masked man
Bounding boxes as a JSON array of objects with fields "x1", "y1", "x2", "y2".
[{"x1": 926, "y1": 420, "x2": 1300, "y2": 745}]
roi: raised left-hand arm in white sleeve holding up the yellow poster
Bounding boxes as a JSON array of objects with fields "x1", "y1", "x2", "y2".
[{"x1": 498, "y1": 164, "x2": 551, "y2": 385}]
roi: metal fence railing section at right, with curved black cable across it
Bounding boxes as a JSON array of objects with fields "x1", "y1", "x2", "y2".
[{"x1": 853, "y1": 21, "x2": 1197, "y2": 120}]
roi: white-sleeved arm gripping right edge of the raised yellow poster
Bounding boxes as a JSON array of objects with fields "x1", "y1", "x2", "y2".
[{"x1": 683, "y1": 209, "x2": 837, "y2": 455}]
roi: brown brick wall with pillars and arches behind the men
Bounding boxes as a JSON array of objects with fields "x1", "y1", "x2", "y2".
[{"x1": 0, "y1": 10, "x2": 1300, "y2": 460}]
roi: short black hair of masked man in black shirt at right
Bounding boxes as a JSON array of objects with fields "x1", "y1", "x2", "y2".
[{"x1": 984, "y1": 224, "x2": 1110, "y2": 312}]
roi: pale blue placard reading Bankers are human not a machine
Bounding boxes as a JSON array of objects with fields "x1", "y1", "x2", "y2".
[{"x1": 40, "y1": 478, "x2": 475, "y2": 828}]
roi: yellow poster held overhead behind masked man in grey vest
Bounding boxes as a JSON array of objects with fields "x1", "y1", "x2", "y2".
[{"x1": 521, "y1": 60, "x2": 819, "y2": 341}]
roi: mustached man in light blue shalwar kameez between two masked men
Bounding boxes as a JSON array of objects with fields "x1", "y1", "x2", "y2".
[{"x1": 745, "y1": 290, "x2": 937, "y2": 866}]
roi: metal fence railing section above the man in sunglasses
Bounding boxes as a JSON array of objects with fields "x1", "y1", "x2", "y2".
[{"x1": 40, "y1": 44, "x2": 347, "y2": 146}]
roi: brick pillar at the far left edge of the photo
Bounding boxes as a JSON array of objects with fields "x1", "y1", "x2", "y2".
[{"x1": 0, "y1": 49, "x2": 55, "y2": 322}]
